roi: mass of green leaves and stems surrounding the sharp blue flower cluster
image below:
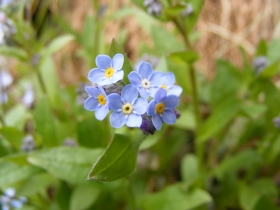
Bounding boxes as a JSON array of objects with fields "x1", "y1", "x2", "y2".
[{"x1": 0, "y1": 0, "x2": 280, "y2": 210}]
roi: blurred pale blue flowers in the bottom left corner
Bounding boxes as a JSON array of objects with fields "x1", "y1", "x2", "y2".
[{"x1": 0, "y1": 188, "x2": 27, "y2": 210}]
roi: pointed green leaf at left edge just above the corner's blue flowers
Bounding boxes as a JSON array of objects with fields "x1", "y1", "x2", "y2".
[{"x1": 0, "y1": 162, "x2": 40, "y2": 189}]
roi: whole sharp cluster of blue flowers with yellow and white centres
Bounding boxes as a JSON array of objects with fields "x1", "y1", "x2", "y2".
[{"x1": 84, "y1": 54, "x2": 182, "y2": 134}]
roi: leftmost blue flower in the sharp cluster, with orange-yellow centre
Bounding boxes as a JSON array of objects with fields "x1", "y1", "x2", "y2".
[{"x1": 84, "y1": 86, "x2": 109, "y2": 120}]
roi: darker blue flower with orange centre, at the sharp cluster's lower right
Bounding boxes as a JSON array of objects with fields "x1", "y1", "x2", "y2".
[{"x1": 147, "y1": 88, "x2": 179, "y2": 130}]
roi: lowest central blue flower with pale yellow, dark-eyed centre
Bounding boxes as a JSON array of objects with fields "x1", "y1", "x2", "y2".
[{"x1": 108, "y1": 85, "x2": 148, "y2": 128}]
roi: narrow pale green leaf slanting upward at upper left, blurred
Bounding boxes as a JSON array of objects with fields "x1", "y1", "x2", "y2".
[{"x1": 41, "y1": 34, "x2": 75, "y2": 60}]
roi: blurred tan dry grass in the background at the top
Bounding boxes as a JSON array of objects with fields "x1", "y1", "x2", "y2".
[{"x1": 53, "y1": 0, "x2": 280, "y2": 83}]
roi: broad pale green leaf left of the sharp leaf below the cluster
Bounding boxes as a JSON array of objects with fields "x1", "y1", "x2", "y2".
[{"x1": 28, "y1": 147, "x2": 102, "y2": 183}]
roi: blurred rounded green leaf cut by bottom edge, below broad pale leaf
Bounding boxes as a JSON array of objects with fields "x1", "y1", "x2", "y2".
[{"x1": 70, "y1": 183, "x2": 100, "y2": 210}]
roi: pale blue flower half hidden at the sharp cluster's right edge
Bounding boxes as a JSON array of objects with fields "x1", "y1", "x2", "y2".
[{"x1": 151, "y1": 72, "x2": 182, "y2": 97}]
